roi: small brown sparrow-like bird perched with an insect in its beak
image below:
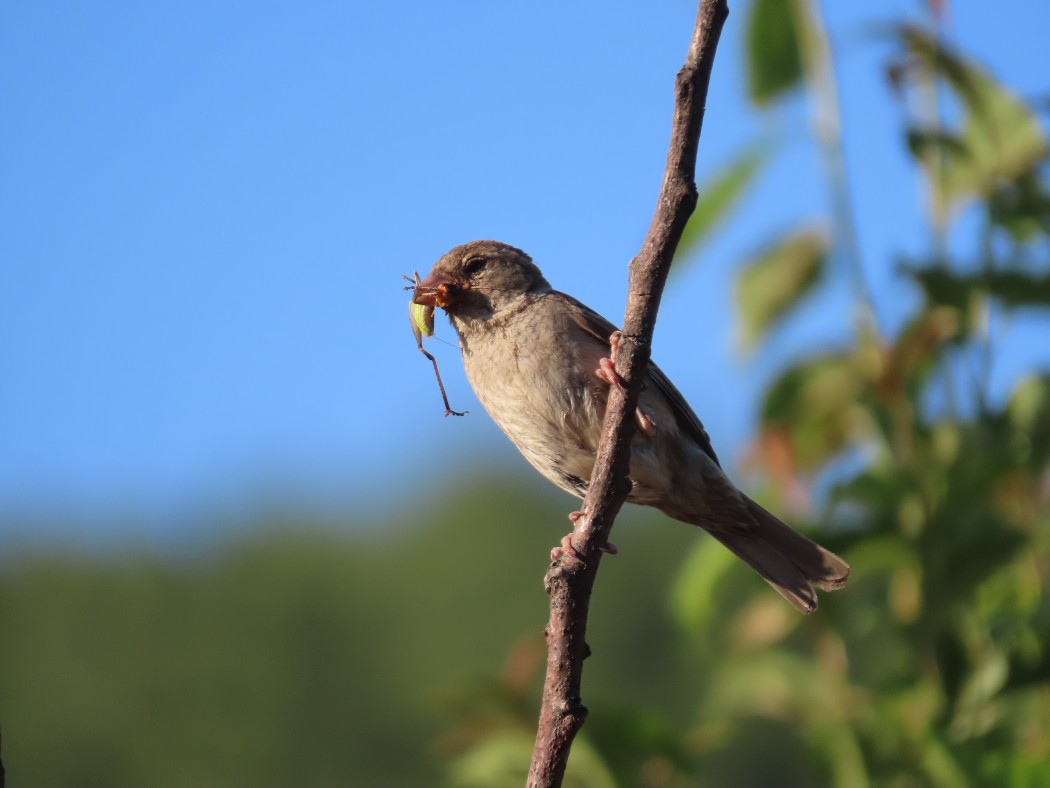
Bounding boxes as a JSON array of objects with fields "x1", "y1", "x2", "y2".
[{"x1": 413, "y1": 241, "x2": 851, "y2": 614}]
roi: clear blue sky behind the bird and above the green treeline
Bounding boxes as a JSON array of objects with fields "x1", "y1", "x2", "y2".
[{"x1": 0, "y1": 0, "x2": 1050, "y2": 538}]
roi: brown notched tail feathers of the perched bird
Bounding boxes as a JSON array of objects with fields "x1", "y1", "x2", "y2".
[{"x1": 697, "y1": 497, "x2": 849, "y2": 613}]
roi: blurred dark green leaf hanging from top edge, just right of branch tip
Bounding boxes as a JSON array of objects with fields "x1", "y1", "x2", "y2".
[{"x1": 747, "y1": 0, "x2": 803, "y2": 106}]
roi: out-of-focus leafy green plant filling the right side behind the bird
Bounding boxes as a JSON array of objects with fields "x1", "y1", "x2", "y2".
[{"x1": 440, "y1": 0, "x2": 1050, "y2": 787}]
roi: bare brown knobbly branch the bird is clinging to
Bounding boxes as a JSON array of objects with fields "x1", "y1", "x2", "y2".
[{"x1": 528, "y1": 0, "x2": 729, "y2": 788}]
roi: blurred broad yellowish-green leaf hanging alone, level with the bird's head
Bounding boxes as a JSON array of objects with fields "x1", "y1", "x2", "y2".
[{"x1": 736, "y1": 230, "x2": 827, "y2": 349}]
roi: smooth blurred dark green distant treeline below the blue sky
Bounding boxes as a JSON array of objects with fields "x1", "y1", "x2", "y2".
[{"x1": 0, "y1": 485, "x2": 695, "y2": 788}]
